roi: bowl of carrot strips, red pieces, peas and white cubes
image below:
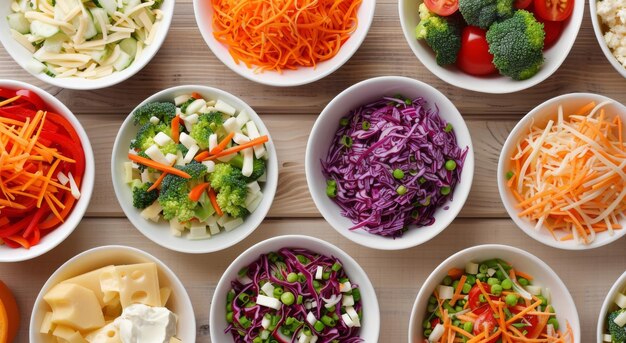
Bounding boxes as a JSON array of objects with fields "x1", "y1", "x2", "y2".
[{"x1": 409, "y1": 244, "x2": 581, "y2": 343}]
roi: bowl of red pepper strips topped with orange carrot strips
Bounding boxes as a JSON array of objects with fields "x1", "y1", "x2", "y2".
[{"x1": 0, "y1": 80, "x2": 95, "y2": 262}]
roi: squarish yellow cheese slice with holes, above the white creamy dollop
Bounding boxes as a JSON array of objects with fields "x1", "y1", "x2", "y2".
[{"x1": 116, "y1": 263, "x2": 161, "y2": 308}]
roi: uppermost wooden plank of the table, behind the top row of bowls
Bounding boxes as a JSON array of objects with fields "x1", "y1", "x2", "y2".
[{"x1": 0, "y1": 0, "x2": 626, "y2": 116}]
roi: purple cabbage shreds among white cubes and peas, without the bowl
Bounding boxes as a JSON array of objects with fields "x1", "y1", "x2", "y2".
[{"x1": 225, "y1": 248, "x2": 363, "y2": 343}]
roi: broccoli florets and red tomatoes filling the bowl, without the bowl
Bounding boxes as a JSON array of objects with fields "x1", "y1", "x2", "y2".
[{"x1": 415, "y1": 0, "x2": 574, "y2": 80}]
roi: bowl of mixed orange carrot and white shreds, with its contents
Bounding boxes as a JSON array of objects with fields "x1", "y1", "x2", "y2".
[{"x1": 498, "y1": 93, "x2": 626, "y2": 250}]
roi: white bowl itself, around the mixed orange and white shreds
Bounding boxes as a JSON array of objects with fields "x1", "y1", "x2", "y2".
[{"x1": 497, "y1": 93, "x2": 626, "y2": 250}]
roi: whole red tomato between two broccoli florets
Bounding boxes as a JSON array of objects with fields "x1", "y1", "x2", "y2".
[{"x1": 456, "y1": 26, "x2": 496, "y2": 76}]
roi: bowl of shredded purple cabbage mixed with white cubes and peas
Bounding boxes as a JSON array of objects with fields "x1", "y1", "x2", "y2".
[{"x1": 210, "y1": 235, "x2": 380, "y2": 343}]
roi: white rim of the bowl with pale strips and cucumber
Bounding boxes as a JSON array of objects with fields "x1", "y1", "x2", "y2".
[{"x1": 0, "y1": 0, "x2": 176, "y2": 91}]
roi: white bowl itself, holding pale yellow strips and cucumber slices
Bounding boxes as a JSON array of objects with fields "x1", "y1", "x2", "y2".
[{"x1": 0, "y1": 0, "x2": 175, "y2": 90}]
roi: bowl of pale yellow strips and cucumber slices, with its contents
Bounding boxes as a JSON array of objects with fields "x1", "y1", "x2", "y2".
[{"x1": 0, "y1": 0, "x2": 175, "y2": 90}]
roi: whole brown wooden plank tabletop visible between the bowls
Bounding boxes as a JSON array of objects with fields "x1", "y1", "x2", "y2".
[{"x1": 0, "y1": 0, "x2": 626, "y2": 343}]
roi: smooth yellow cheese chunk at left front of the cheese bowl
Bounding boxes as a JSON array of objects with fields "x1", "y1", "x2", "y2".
[{"x1": 43, "y1": 283, "x2": 104, "y2": 331}]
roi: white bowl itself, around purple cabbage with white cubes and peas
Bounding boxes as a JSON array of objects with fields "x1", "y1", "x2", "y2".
[{"x1": 209, "y1": 235, "x2": 380, "y2": 343}]
